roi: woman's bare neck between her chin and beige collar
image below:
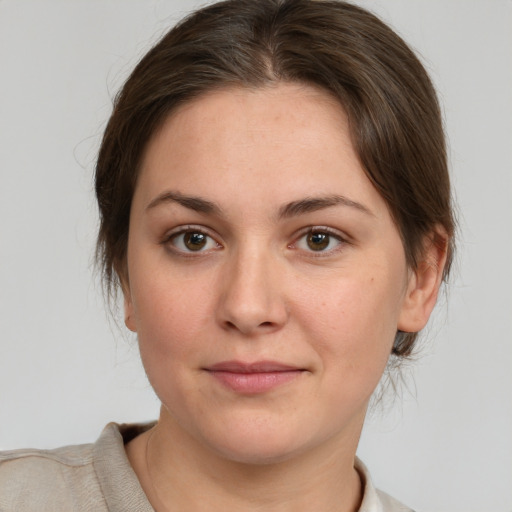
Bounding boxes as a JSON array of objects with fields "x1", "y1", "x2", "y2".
[{"x1": 127, "y1": 413, "x2": 362, "y2": 512}]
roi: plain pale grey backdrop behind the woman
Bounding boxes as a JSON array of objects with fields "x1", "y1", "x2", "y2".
[{"x1": 0, "y1": 0, "x2": 512, "y2": 512}]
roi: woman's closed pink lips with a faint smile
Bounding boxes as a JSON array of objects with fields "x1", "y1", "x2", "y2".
[{"x1": 206, "y1": 361, "x2": 304, "y2": 394}]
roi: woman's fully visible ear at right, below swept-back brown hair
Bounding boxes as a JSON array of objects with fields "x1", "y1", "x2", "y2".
[{"x1": 397, "y1": 226, "x2": 449, "y2": 332}]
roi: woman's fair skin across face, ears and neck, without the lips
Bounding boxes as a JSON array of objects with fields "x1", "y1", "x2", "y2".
[{"x1": 123, "y1": 84, "x2": 444, "y2": 511}]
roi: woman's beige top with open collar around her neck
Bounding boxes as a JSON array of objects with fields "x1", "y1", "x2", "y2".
[{"x1": 0, "y1": 423, "x2": 412, "y2": 512}]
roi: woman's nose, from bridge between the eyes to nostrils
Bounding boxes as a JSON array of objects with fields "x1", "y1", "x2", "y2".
[{"x1": 217, "y1": 250, "x2": 288, "y2": 336}]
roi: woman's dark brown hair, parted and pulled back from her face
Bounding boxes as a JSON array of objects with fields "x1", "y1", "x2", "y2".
[{"x1": 96, "y1": 0, "x2": 454, "y2": 356}]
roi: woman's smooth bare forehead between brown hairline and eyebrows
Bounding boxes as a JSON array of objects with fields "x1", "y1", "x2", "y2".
[{"x1": 136, "y1": 83, "x2": 388, "y2": 218}]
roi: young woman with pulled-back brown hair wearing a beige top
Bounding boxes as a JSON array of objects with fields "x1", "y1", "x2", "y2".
[{"x1": 0, "y1": 0, "x2": 454, "y2": 511}]
